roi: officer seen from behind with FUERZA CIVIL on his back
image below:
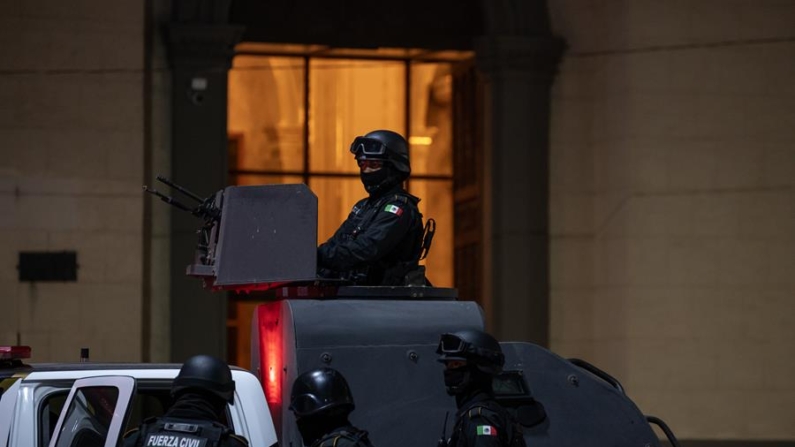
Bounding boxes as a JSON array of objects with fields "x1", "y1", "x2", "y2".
[{"x1": 124, "y1": 355, "x2": 248, "y2": 447}]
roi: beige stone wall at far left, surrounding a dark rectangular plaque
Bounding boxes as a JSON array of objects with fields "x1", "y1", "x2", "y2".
[{"x1": 0, "y1": 0, "x2": 145, "y2": 361}]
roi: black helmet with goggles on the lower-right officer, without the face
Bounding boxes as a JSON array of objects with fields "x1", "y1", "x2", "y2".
[{"x1": 436, "y1": 329, "x2": 505, "y2": 374}]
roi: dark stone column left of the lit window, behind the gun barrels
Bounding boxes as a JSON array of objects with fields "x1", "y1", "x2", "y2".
[{"x1": 167, "y1": 1, "x2": 242, "y2": 362}]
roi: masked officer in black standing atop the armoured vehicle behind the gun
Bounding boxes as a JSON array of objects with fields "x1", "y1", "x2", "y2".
[{"x1": 317, "y1": 130, "x2": 430, "y2": 285}]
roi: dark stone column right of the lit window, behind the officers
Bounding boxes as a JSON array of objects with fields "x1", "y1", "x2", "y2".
[{"x1": 475, "y1": 31, "x2": 565, "y2": 346}]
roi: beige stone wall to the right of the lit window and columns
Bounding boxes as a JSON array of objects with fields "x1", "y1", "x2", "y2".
[{"x1": 550, "y1": 0, "x2": 795, "y2": 440}]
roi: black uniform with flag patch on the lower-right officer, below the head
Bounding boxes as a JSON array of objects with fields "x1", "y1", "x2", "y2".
[{"x1": 448, "y1": 393, "x2": 525, "y2": 447}]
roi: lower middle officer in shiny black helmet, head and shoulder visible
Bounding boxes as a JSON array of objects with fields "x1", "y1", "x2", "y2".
[{"x1": 290, "y1": 368, "x2": 373, "y2": 447}]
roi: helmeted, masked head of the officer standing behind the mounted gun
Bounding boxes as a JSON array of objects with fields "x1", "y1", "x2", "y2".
[{"x1": 351, "y1": 130, "x2": 411, "y2": 195}]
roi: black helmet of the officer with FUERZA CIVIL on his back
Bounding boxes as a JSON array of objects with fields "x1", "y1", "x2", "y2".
[{"x1": 171, "y1": 355, "x2": 235, "y2": 403}]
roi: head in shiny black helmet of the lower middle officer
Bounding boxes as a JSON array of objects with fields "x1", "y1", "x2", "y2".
[{"x1": 290, "y1": 368, "x2": 355, "y2": 446}]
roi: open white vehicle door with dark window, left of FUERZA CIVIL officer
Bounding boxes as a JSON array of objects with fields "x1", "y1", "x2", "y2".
[{"x1": 49, "y1": 376, "x2": 136, "y2": 447}]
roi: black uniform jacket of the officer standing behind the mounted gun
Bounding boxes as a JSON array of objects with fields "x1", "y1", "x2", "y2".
[{"x1": 317, "y1": 185, "x2": 423, "y2": 285}]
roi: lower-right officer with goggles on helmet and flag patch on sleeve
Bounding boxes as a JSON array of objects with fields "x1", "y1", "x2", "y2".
[{"x1": 436, "y1": 329, "x2": 525, "y2": 447}]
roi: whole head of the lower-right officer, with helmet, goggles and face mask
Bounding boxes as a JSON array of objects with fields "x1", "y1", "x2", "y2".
[{"x1": 436, "y1": 329, "x2": 505, "y2": 396}]
